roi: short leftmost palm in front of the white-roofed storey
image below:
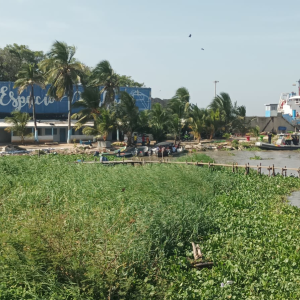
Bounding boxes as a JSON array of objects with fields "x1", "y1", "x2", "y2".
[{"x1": 4, "y1": 110, "x2": 32, "y2": 144}]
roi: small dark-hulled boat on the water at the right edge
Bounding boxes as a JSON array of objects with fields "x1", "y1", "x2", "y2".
[{"x1": 255, "y1": 132, "x2": 300, "y2": 150}]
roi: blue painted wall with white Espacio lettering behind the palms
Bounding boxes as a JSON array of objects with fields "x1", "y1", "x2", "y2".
[{"x1": 0, "y1": 81, "x2": 151, "y2": 114}]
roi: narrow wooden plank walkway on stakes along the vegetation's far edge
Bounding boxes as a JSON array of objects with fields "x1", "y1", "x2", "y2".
[{"x1": 83, "y1": 159, "x2": 300, "y2": 178}]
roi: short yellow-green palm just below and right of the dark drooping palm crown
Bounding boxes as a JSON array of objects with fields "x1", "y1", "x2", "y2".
[{"x1": 82, "y1": 109, "x2": 116, "y2": 141}]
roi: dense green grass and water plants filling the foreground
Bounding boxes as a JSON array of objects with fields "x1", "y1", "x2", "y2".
[{"x1": 0, "y1": 155, "x2": 300, "y2": 300}]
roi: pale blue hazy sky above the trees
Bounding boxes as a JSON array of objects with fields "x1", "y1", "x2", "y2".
[{"x1": 0, "y1": 0, "x2": 300, "y2": 116}]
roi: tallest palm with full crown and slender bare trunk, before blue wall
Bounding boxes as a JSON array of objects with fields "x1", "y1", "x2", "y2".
[{"x1": 40, "y1": 41, "x2": 83, "y2": 143}]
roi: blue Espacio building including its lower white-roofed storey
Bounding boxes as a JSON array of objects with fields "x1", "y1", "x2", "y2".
[{"x1": 0, "y1": 81, "x2": 151, "y2": 142}]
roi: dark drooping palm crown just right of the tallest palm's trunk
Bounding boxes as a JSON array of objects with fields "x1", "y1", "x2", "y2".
[{"x1": 72, "y1": 87, "x2": 100, "y2": 128}]
